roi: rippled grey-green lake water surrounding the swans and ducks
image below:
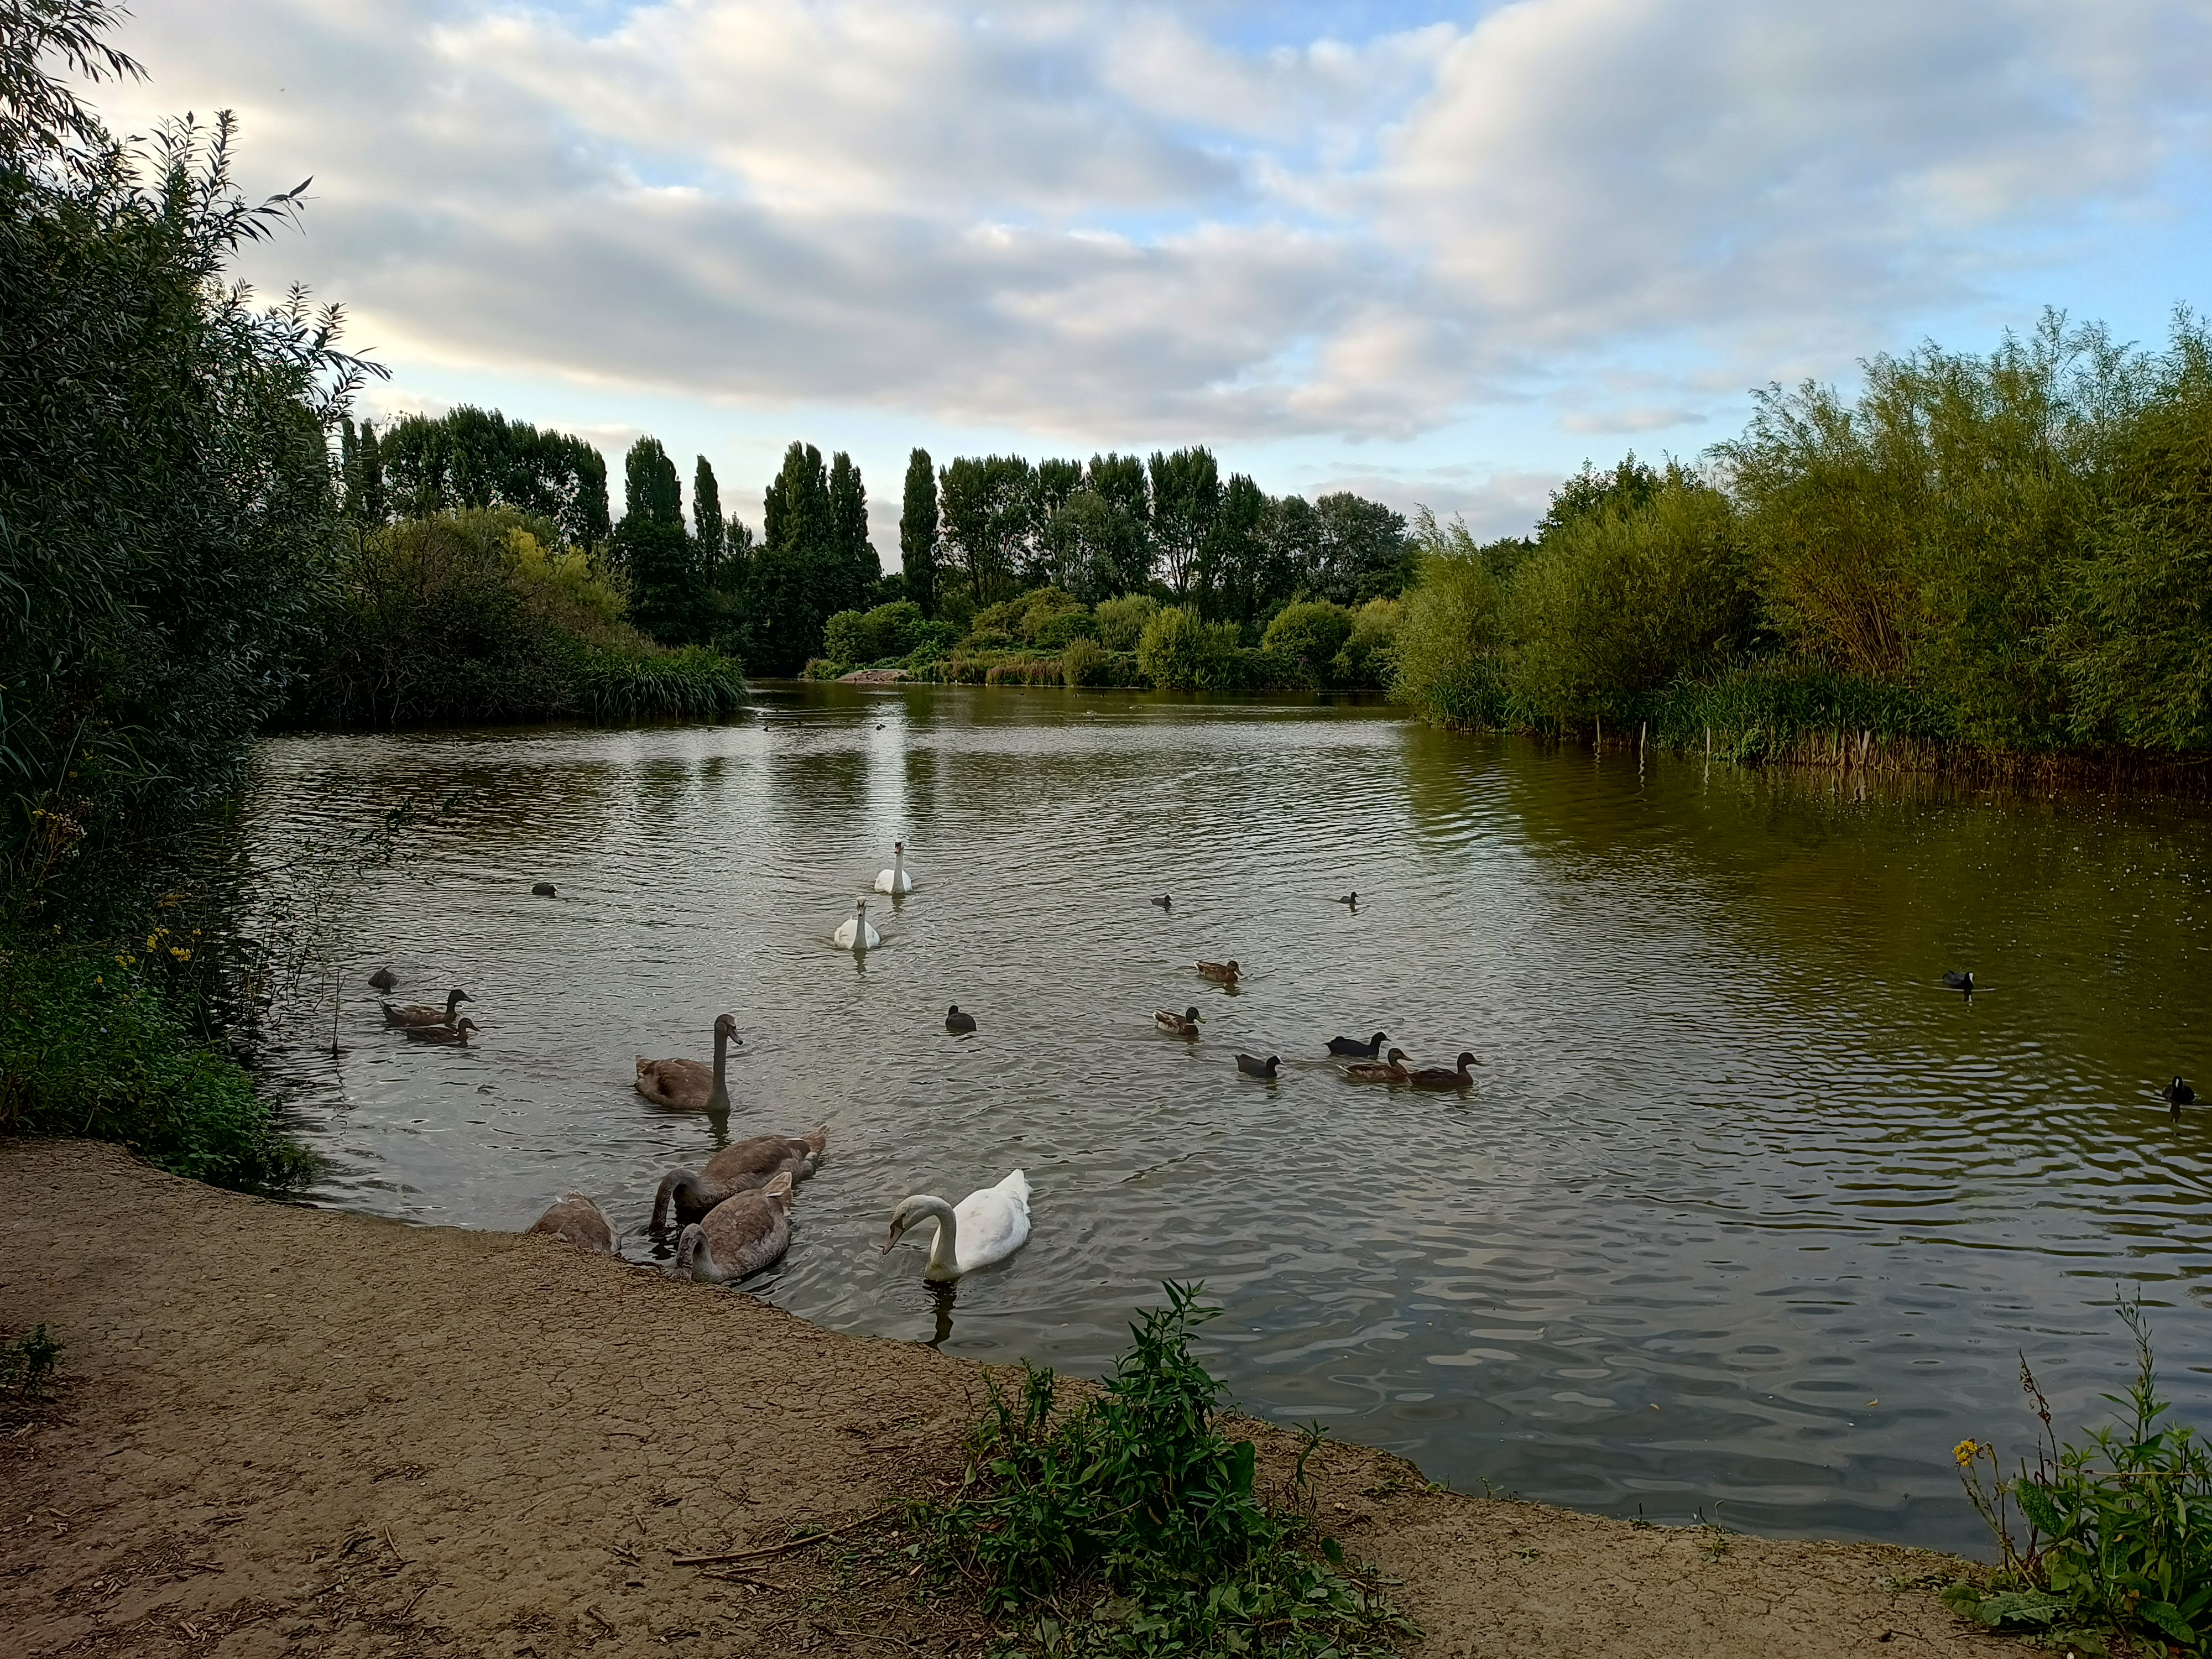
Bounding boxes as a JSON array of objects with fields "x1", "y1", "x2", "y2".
[{"x1": 252, "y1": 688, "x2": 2212, "y2": 1548}]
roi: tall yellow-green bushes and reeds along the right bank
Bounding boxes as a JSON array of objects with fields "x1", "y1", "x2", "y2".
[{"x1": 1396, "y1": 314, "x2": 2212, "y2": 763}]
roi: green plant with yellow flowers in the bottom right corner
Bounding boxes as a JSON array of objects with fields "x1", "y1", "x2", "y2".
[{"x1": 1944, "y1": 1296, "x2": 2212, "y2": 1652}]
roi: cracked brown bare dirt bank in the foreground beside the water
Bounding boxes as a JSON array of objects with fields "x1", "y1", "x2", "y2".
[{"x1": 0, "y1": 1141, "x2": 2020, "y2": 1659}]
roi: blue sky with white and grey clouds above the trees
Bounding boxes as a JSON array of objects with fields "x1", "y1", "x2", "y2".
[{"x1": 95, "y1": 0, "x2": 2212, "y2": 553}]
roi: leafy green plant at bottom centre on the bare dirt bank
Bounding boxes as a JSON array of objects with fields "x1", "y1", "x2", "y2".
[{"x1": 914, "y1": 1283, "x2": 1416, "y2": 1659}]
